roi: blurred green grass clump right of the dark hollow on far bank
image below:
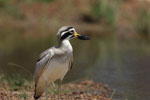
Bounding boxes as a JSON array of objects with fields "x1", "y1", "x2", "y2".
[{"x1": 91, "y1": 0, "x2": 119, "y2": 26}]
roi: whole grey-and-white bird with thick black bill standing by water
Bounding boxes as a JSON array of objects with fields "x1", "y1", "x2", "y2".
[{"x1": 34, "y1": 26, "x2": 90, "y2": 100}]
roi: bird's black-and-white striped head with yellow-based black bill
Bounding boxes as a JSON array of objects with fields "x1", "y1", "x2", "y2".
[{"x1": 57, "y1": 26, "x2": 90, "y2": 41}]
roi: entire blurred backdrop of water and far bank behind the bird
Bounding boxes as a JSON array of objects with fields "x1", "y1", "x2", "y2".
[{"x1": 0, "y1": 0, "x2": 150, "y2": 100}]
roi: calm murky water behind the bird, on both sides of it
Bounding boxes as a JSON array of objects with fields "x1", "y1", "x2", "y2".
[{"x1": 0, "y1": 33, "x2": 150, "y2": 100}]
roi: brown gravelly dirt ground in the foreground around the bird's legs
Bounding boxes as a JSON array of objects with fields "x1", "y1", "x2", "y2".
[{"x1": 0, "y1": 80, "x2": 112, "y2": 100}]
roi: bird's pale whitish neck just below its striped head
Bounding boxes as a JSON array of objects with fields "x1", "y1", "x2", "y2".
[{"x1": 60, "y1": 40, "x2": 73, "y2": 52}]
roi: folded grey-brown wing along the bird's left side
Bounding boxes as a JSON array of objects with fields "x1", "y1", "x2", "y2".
[{"x1": 34, "y1": 49, "x2": 53, "y2": 83}]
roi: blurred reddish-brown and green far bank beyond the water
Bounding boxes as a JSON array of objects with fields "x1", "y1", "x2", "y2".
[{"x1": 0, "y1": 0, "x2": 150, "y2": 35}]
